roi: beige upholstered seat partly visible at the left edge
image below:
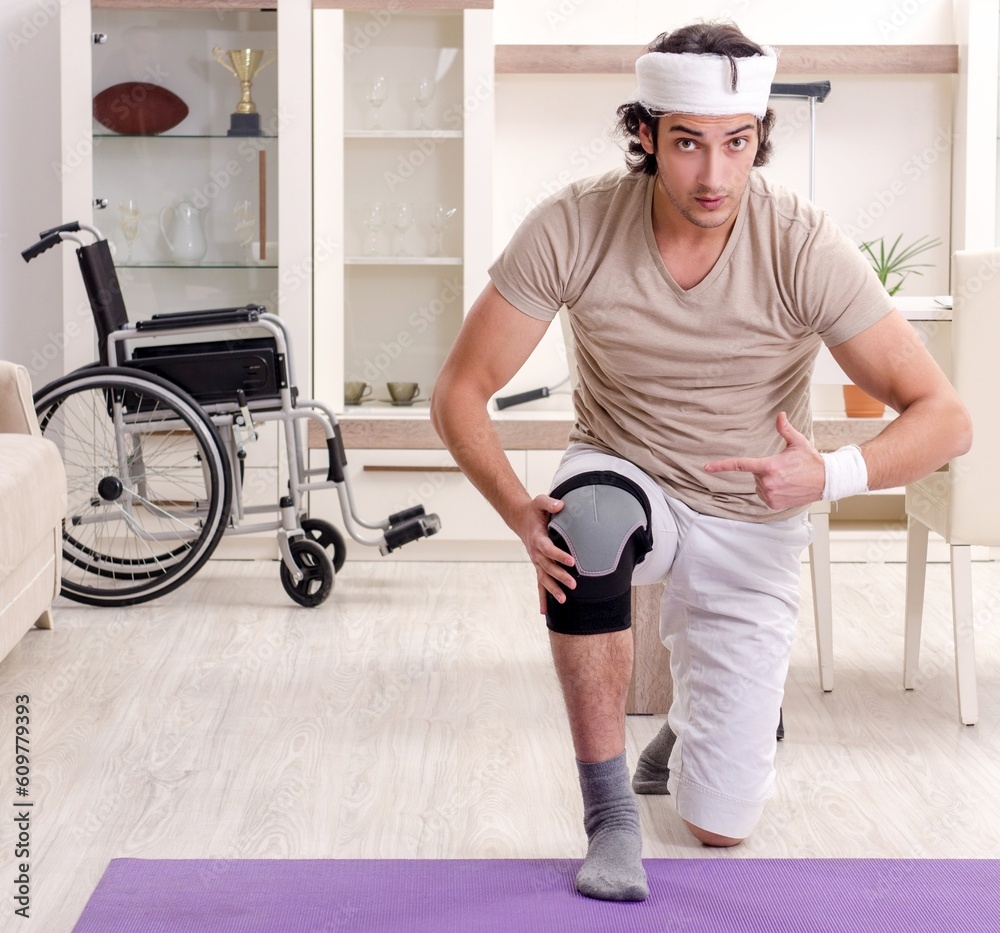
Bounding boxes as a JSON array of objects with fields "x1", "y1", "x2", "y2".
[{"x1": 0, "y1": 361, "x2": 66, "y2": 658}]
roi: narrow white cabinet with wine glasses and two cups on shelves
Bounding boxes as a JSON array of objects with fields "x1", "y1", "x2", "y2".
[{"x1": 313, "y1": 4, "x2": 493, "y2": 418}]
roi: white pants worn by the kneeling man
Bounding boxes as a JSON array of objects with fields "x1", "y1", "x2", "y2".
[{"x1": 552, "y1": 444, "x2": 812, "y2": 839}]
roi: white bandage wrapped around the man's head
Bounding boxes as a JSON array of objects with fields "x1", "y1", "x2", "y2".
[{"x1": 633, "y1": 46, "x2": 778, "y2": 119}]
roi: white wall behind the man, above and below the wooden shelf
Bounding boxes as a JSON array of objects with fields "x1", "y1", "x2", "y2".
[{"x1": 494, "y1": 0, "x2": 957, "y2": 396}]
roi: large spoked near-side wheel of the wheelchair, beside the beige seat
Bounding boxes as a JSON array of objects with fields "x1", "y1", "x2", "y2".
[{"x1": 35, "y1": 367, "x2": 232, "y2": 606}]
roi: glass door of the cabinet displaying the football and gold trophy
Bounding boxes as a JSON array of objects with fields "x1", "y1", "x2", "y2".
[{"x1": 88, "y1": 8, "x2": 284, "y2": 316}]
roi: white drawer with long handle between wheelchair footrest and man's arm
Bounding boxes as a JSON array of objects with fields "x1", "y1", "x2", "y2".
[{"x1": 338, "y1": 449, "x2": 527, "y2": 541}]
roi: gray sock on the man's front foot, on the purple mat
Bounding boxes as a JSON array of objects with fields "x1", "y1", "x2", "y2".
[{"x1": 576, "y1": 752, "x2": 649, "y2": 901}]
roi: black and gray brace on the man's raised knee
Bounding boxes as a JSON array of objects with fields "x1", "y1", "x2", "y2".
[{"x1": 545, "y1": 470, "x2": 653, "y2": 635}]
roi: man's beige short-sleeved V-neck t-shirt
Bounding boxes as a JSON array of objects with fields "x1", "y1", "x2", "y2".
[{"x1": 490, "y1": 171, "x2": 893, "y2": 522}]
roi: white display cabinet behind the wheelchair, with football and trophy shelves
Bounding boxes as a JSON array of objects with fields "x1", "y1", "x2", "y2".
[{"x1": 61, "y1": 0, "x2": 313, "y2": 556}]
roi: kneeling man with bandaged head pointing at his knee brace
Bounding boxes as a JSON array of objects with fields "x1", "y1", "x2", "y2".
[{"x1": 432, "y1": 24, "x2": 971, "y2": 900}]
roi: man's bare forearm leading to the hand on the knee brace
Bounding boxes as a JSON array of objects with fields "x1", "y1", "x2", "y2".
[{"x1": 431, "y1": 390, "x2": 531, "y2": 530}]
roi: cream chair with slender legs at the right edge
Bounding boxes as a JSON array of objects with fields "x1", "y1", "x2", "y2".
[{"x1": 903, "y1": 250, "x2": 1000, "y2": 725}]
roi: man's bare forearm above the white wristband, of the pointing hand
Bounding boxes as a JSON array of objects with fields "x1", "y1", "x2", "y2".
[{"x1": 861, "y1": 398, "x2": 972, "y2": 489}]
